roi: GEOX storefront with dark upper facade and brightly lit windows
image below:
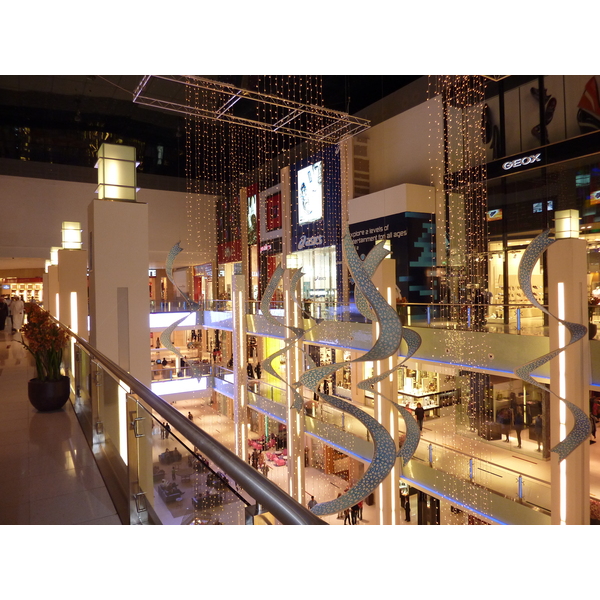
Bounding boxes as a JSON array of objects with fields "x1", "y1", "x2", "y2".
[{"x1": 486, "y1": 75, "x2": 600, "y2": 323}]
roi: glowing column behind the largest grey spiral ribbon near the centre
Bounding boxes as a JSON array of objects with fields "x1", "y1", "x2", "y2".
[{"x1": 372, "y1": 258, "x2": 401, "y2": 525}]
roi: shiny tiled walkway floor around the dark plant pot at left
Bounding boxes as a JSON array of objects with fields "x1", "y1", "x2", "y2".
[{"x1": 0, "y1": 331, "x2": 121, "y2": 525}]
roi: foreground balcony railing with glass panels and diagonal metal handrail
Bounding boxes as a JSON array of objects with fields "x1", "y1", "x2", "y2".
[{"x1": 58, "y1": 328, "x2": 325, "y2": 525}]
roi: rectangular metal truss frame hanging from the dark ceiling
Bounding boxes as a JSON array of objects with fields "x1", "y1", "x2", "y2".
[{"x1": 133, "y1": 75, "x2": 370, "y2": 144}]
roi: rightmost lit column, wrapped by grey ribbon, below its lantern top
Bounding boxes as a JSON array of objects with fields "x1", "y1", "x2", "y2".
[{"x1": 548, "y1": 238, "x2": 590, "y2": 525}]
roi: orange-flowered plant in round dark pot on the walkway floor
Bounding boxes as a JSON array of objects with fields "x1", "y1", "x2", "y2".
[{"x1": 21, "y1": 304, "x2": 71, "y2": 411}]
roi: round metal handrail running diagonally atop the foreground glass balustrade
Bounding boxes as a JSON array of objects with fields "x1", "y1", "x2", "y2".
[{"x1": 58, "y1": 317, "x2": 328, "y2": 525}]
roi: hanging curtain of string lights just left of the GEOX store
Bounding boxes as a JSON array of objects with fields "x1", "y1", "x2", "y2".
[{"x1": 429, "y1": 75, "x2": 494, "y2": 514}]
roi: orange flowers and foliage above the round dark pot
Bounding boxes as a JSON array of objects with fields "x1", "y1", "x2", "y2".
[{"x1": 21, "y1": 304, "x2": 69, "y2": 381}]
